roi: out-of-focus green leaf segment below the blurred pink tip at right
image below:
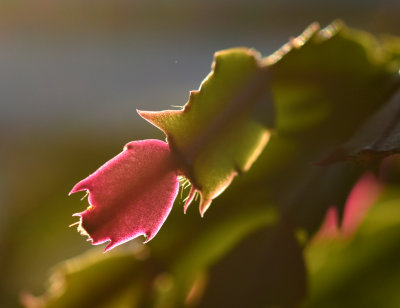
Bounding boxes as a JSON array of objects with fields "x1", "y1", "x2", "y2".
[{"x1": 303, "y1": 185, "x2": 400, "y2": 308}]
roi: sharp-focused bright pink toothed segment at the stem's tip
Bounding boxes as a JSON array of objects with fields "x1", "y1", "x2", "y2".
[{"x1": 70, "y1": 140, "x2": 179, "y2": 251}]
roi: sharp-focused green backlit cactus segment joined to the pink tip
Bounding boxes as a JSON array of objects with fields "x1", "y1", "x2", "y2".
[{"x1": 139, "y1": 48, "x2": 271, "y2": 215}]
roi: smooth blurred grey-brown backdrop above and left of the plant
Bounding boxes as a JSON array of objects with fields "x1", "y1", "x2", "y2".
[{"x1": 0, "y1": 0, "x2": 400, "y2": 307}]
